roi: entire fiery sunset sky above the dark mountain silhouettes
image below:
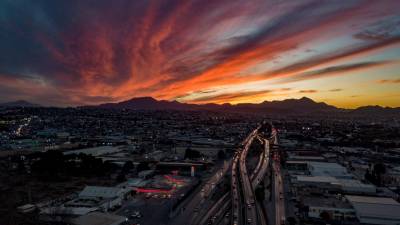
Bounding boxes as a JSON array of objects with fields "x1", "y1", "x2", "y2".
[{"x1": 0, "y1": 0, "x2": 400, "y2": 108}]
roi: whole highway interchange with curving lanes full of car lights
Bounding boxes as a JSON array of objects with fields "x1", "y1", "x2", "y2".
[{"x1": 181, "y1": 124, "x2": 285, "y2": 225}]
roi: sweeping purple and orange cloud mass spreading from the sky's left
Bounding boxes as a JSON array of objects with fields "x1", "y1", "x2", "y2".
[{"x1": 0, "y1": 0, "x2": 399, "y2": 105}]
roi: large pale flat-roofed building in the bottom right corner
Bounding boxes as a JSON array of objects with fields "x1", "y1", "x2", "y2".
[{"x1": 345, "y1": 195, "x2": 400, "y2": 225}]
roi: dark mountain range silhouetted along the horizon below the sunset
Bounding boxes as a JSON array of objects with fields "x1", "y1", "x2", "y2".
[{"x1": 0, "y1": 97, "x2": 400, "y2": 117}]
